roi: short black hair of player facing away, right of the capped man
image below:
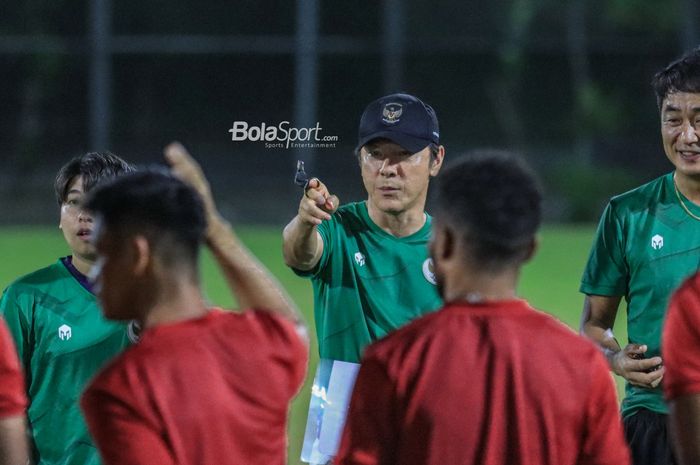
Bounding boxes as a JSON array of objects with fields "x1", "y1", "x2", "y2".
[{"x1": 435, "y1": 150, "x2": 542, "y2": 271}]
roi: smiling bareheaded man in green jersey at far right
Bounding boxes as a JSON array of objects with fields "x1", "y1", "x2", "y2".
[{"x1": 580, "y1": 49, "x2": 700, "y2": 465}]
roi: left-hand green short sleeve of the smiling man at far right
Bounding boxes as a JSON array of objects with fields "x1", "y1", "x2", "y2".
[{"x1": 579, "y1": 202, "x2": 629, "y2": 296}]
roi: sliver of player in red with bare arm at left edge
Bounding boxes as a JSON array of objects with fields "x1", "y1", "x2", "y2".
[{"x1": 0, "y1": 318, "x2": 29, "y2": 465}]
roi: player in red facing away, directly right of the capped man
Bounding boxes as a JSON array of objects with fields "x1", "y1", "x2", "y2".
[{"x1": 338, "y1": 152, "x2": 629, "y2": 465}]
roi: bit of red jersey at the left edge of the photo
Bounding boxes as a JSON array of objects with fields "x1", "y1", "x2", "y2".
[{"x1": 0, "y1": 318, "x2": 27, "y2": 418}]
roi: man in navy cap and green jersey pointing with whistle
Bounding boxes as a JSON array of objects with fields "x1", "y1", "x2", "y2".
[{"x1": 283, "y1": 94, "x2": 445, "y2": 363}]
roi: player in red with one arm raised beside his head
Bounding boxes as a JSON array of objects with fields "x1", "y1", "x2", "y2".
[{"x1": 82, "y1": 144, "x2": 308, "y2": 465}]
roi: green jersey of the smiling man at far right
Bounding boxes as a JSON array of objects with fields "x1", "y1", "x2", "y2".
[{"x1": 580, "y1": 173, "x2": 700, "y2": 417}]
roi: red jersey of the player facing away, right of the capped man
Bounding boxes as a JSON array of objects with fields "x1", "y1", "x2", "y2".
[{"x1": 338, "y1": 300, "x2": 630, "y2": 465}]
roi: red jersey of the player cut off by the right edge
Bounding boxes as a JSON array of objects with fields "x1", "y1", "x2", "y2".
[{"x1": 661, "y1": 274, "x2": 700, "y2": 400}]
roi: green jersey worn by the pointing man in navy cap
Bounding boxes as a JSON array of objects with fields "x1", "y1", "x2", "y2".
[{"x1": 295, "y1": 202, "x2": 442, "y2": 363}]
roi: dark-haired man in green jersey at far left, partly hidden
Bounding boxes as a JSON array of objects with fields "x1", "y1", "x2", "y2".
[{"x1": 0, "y1": 152, "x2": 132, "y2": 465}]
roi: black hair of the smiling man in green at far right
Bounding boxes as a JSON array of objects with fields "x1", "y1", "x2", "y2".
[{"x1": 651, "y1": 47, "x2": 700, "y2": 109}]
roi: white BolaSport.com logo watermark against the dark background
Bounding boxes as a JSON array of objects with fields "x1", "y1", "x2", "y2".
[{"x1": 228, "y1": 121, "x2": 338, "y2": 149}]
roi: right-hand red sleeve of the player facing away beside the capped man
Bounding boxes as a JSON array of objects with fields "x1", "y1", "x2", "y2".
[{"x1": 577, "y1": 350, "x2": 630, "y2": 465}]
